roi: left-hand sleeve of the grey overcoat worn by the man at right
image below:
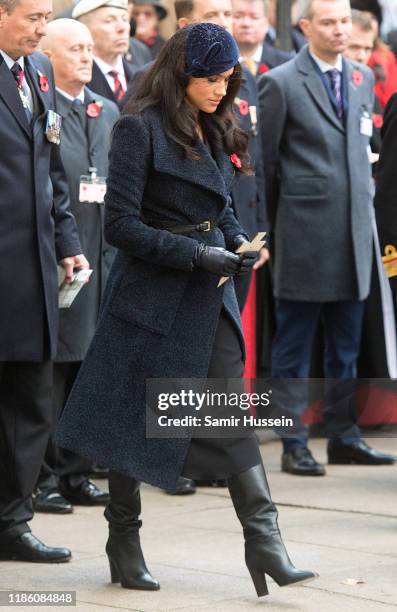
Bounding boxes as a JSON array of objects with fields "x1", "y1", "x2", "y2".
[{"x1": 258, "y1": 75, "x2": 287, "y2": 227}]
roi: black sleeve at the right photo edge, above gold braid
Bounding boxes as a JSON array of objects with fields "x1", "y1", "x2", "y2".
[{"x1": 375, "y1": 94, "x2": 397, "y2": 285}]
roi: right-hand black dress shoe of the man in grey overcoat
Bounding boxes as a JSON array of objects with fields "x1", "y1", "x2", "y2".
[{"x1": 328, "y1": 440, "x2": 397, "y2": 465}]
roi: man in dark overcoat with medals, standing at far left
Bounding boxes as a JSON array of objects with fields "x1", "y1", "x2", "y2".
[{"x1": 0, "y1": 0, "x2": 88, "y2": 562}]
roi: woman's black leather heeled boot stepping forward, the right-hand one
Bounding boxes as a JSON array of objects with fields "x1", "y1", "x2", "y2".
[{"x1": 228, "y1": 464, "x2": 318, "y2": 597}]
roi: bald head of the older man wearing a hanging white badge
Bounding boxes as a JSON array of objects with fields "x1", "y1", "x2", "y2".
[{"x1": 40, "y1": 19, "x2": 94, "y2": 97}]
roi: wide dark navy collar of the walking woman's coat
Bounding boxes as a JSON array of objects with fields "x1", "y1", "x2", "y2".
[{"x1": 150, "y1": 111, "x2": 234, "y2": 200}]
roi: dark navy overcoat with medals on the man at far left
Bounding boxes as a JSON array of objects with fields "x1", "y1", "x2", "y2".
[{"x1": 0, "y1": 53, "x2": 81, "y2": 361}]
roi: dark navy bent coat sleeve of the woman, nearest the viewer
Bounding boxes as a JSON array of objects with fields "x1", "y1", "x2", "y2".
[{"x1": 105, "y1": 115, "x2": 198, "y2": 271}]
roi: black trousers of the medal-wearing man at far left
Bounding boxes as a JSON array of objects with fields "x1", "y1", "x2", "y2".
[{"x1": 0, "y1": 361, "x2": 53, "y2": 541}]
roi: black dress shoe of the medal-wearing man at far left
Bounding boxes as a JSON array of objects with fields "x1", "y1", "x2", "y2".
[{"x1": 0, "y1": 531, "x2": 72, "y2": 563}]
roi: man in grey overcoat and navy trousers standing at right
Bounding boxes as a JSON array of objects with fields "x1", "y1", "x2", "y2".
[{"x1": 259, "y1": 0, "x2": 394, "y2": 475}]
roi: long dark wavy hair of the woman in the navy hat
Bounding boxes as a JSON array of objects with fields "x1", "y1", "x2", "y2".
[{"x1": 123, "y1": 26, "x2": 252, "y2": 174}]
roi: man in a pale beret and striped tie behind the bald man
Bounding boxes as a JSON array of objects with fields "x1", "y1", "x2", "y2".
[{"x1": 72, "y1": 0, "x2": 136, "y2": 105}]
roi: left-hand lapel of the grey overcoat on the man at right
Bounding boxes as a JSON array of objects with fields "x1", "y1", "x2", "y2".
[{"x1": 295, "y1": 47, "x2": 345, "y2": 132}]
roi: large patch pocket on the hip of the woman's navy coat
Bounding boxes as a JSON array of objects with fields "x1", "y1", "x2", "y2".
[{"x1": 109, "y1": 262, "x2": 190, "y2": 336}]
